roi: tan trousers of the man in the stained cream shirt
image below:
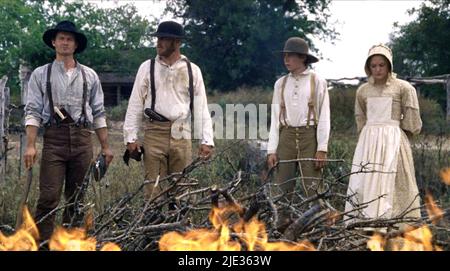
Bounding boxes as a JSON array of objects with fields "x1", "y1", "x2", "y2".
[{"x1": 144, "y1": 121, "x2": 192, "y2": 202}]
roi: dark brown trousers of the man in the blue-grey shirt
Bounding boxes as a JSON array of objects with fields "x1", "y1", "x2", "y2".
[{"x1": 35, "y1": 124, "x2": 93, "y2": 241}]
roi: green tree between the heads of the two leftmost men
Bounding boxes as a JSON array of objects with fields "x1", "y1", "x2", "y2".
[{"x1": 44, "y1": 1, "x2": 154, "y2": 74}]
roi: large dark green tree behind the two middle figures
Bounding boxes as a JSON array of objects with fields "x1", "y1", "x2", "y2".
[{"x1": 166, "y1": 0, "x2": 336, "y2": 90}]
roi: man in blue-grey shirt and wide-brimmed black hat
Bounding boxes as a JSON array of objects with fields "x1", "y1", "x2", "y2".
[{"x1": 25, "y1": 21, "x2": 113, "y2": 244}]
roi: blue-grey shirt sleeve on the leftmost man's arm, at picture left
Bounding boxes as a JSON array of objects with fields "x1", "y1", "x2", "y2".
[{"x1": 25, "y1": 68, "x2": 44, "y2": 127}]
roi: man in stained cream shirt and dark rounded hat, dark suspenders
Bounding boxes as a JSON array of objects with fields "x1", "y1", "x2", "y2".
[{"x1": 124, "y1": 21, "x2": 214, "y2": 207}]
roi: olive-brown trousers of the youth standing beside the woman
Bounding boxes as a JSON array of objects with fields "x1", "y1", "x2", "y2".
[{"x1": 275, "y1": 126, "x2": 322, "y2": 228}]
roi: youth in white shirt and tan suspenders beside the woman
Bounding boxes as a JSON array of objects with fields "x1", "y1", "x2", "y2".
[{"x1": 267, "y1": 37, "x2": 330, "y2": 234}]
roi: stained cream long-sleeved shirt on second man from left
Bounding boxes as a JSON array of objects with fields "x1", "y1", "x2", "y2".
[{"x1": 123, "y1": 55, "x2": 214, "y2": 146}]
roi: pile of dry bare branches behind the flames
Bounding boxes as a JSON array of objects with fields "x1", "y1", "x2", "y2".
[{"x1": 75, "y1": 153, "x2": 450, "y2": 251}]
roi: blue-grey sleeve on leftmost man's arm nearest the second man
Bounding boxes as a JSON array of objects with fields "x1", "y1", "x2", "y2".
[{"x1": 89, "y1": 72, "x2": 106, "y2": 129}]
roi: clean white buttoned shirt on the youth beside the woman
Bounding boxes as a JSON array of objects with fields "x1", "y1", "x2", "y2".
[{"x1": 267, "y1": 69, "x2": 330, "y2": 154}]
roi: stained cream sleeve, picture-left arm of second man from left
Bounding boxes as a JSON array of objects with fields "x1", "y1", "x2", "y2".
[{"x1": 123, "y1": 60, "x2": 150, "y2": 145}]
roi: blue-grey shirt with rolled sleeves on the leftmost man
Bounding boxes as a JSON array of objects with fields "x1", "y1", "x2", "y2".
[{"x1": 25, "y1": 60, "x2": 106, "y2": 129}]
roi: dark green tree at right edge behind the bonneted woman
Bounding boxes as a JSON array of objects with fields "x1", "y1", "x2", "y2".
[{"x1": 390, "y1": 0, "x2": 450, "y2": 108}]
